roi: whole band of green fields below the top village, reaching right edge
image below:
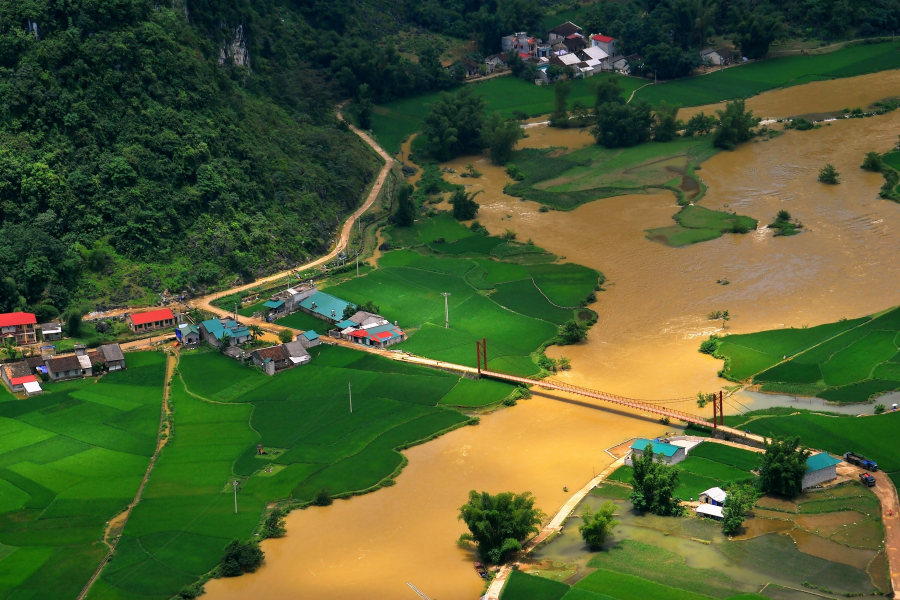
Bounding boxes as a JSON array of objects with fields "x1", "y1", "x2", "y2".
[{"x1": 372, "y1": 42, "x2": 900, "y2": 153}]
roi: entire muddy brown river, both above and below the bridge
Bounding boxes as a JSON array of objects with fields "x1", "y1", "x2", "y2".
[{"x1": 206, "y1": 72, "x2": 900, "y2": 600}]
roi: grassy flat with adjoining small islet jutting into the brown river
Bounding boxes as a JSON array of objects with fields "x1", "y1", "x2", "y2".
[{"x1": 505, "y1": 138, "x2": 757, "y2": 246}]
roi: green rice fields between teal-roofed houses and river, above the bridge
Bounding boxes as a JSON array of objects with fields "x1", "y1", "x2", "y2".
[{"x1": 278, "y1": 214, "x2": 602, "y2": 378}]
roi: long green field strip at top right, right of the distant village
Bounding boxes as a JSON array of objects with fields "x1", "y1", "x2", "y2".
[{"x1": 635, "y1": 43, "x2": 900, "y2": 108}]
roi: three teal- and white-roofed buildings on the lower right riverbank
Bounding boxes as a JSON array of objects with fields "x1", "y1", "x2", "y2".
[{"x1": 625, "y1": 437, "x2": 841, "y2": 520}]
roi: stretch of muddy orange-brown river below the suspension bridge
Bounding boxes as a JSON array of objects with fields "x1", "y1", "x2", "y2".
[{"x1": 206, "y1": 394, "x2": 671, "y2": 600}]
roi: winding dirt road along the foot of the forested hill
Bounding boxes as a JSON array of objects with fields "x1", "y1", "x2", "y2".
[{"x1": 190, "y1": 107, "x2": 394, "y2": 324}]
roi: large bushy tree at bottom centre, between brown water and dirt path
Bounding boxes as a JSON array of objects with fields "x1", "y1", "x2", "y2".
[{"x1": 459, "y1": 490, "x2": 544, "y2": 564}]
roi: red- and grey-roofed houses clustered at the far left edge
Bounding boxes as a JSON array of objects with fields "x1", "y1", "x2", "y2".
[{"x1": 0, "y1": 312, "x2": 125, "y2": 396}]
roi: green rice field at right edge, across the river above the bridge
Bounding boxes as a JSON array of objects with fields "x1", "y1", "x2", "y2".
[{"x1": 716, "y1": 309, "x2": 900, "y2": 403}]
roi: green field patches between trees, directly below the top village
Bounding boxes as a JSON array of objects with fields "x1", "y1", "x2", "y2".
[{"x1": 372, "y1": 74, "x2": 646, "y2": 154}]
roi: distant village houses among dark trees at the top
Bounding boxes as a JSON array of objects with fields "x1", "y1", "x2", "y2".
[{"x1": 472, "y1": 21, "x2": 735, "y2": 85}]
